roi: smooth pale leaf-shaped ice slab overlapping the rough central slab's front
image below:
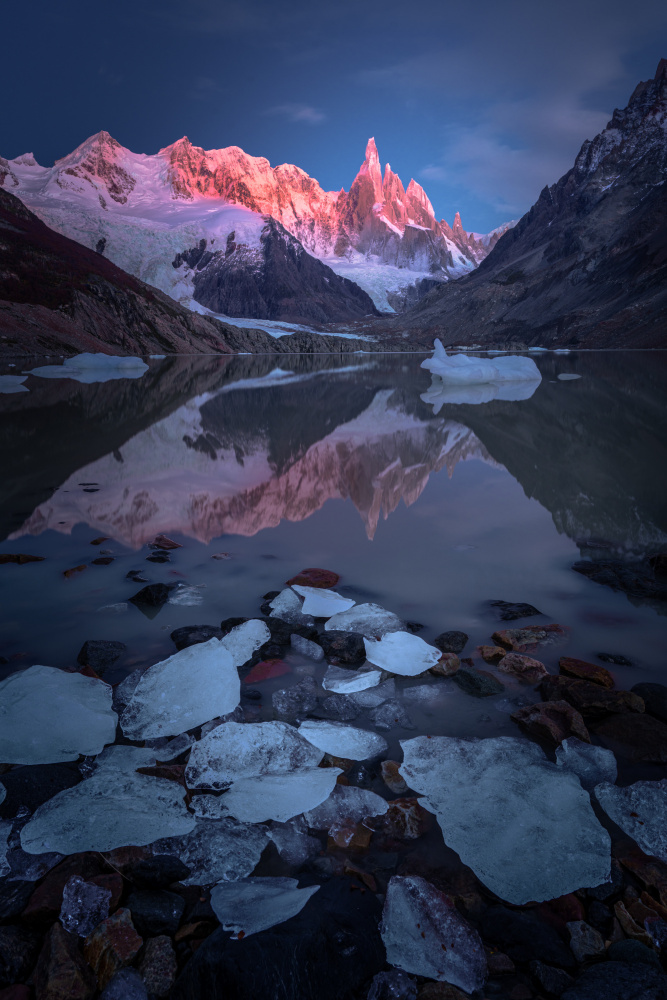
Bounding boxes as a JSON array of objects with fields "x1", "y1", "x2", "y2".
[{"x1": 223, "y1": 767, "x2": 343, "y2": 823}]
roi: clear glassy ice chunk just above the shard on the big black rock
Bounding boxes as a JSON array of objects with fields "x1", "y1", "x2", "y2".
[{"x1": 152, "y1": 820, "x2": 269, "y2": 885}]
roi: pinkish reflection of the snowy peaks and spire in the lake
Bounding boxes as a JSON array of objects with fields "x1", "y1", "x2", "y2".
[{"x1": 14, "y1": 390, "x2": 496, "y2": 547}]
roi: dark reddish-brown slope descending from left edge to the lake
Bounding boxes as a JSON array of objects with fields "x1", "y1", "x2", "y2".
[{"x1": 0, "y1": 188, "x2": 369, "y2": 355}]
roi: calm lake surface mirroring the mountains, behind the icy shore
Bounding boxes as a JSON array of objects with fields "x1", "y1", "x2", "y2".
[{"x1": 0, "y1": 352, "x2": 667, "y2": 750}]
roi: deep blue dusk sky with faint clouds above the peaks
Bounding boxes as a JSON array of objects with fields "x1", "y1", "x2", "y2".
[{"x1": 0, "y1": 0, "x2": 667, "y2": 232}]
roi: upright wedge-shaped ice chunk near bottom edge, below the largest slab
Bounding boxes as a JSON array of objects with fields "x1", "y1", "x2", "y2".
[{"x1": 380, "y1": 875, "x2": 486, "y2": 993}]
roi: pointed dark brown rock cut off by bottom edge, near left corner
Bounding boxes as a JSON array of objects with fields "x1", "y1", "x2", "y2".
[{"x1": 34, "y1": 922, "x2": 96, "y2": 1000}]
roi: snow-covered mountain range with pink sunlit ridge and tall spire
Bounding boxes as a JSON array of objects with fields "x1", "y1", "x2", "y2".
[{"x1": 0, "y1": 132, "x2": 511, "y2": 314}]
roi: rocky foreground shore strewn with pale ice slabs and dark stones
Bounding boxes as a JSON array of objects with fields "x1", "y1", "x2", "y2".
[{"x1": 0, "y1": 564, "x2": 667, "y2": 1000}]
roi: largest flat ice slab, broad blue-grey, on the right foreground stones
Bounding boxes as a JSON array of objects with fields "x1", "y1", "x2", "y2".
[{"x1": 399, "y1": 736, "x2": 611, "y2": 906}]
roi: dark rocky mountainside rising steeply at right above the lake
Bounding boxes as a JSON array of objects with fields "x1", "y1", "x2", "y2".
[{"x1": 402, "y1": 59, "x2": 667, "y2": 347}]
